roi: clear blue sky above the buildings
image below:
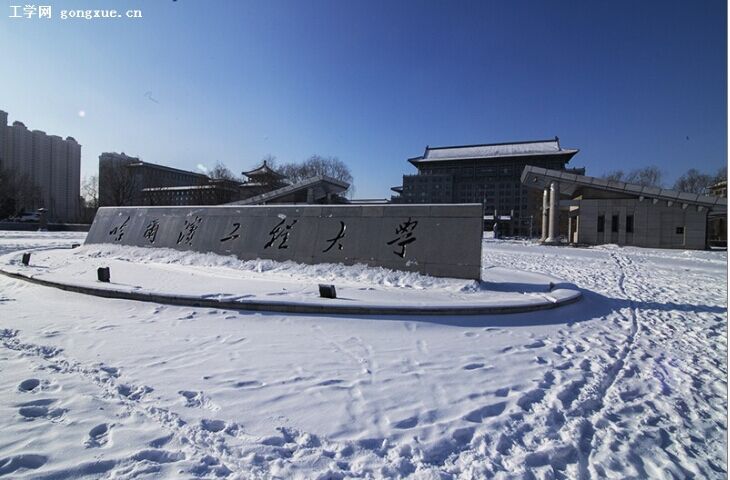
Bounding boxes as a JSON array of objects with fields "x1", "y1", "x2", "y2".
[{"x1": 0, "y1": 0, "x2": 727, "y2": 198}]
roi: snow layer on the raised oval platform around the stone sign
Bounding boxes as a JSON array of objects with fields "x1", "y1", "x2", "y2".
[{"x1": 0, "y1": 245, "x2": 580, "y2": 314}]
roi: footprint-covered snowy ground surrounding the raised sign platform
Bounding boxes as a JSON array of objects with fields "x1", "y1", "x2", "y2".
[{"x1": 0, "y1": 232, "x2": 727, "y2": 479}]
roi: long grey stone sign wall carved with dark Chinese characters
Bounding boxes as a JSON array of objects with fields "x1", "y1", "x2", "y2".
[{"x1": 86, "y1": 204, "x2": 483, "y2": 279}]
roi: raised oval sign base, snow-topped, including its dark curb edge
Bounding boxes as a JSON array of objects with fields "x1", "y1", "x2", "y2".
[{"x1": 0, "y1": 247, "x2": 581, "y2": 315}]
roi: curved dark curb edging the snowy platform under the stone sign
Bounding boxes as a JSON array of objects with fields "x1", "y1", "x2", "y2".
[{"x1": 0, "y1": 269, "x2": 583, "y2": 315}]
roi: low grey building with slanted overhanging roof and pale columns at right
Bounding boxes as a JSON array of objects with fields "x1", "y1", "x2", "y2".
[{"x1": 521, "y1": 166, "x2": 727, "y2": 249}]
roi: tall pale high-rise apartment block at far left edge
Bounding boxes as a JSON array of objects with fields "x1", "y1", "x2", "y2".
[{"x1": 0, "y1": 110, "x2": 81, "y2": 222}]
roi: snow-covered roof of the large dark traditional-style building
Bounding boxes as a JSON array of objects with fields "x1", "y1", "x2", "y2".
[{"x1": 408, "y1": 137, "x2": 578, "y2": 165}]
